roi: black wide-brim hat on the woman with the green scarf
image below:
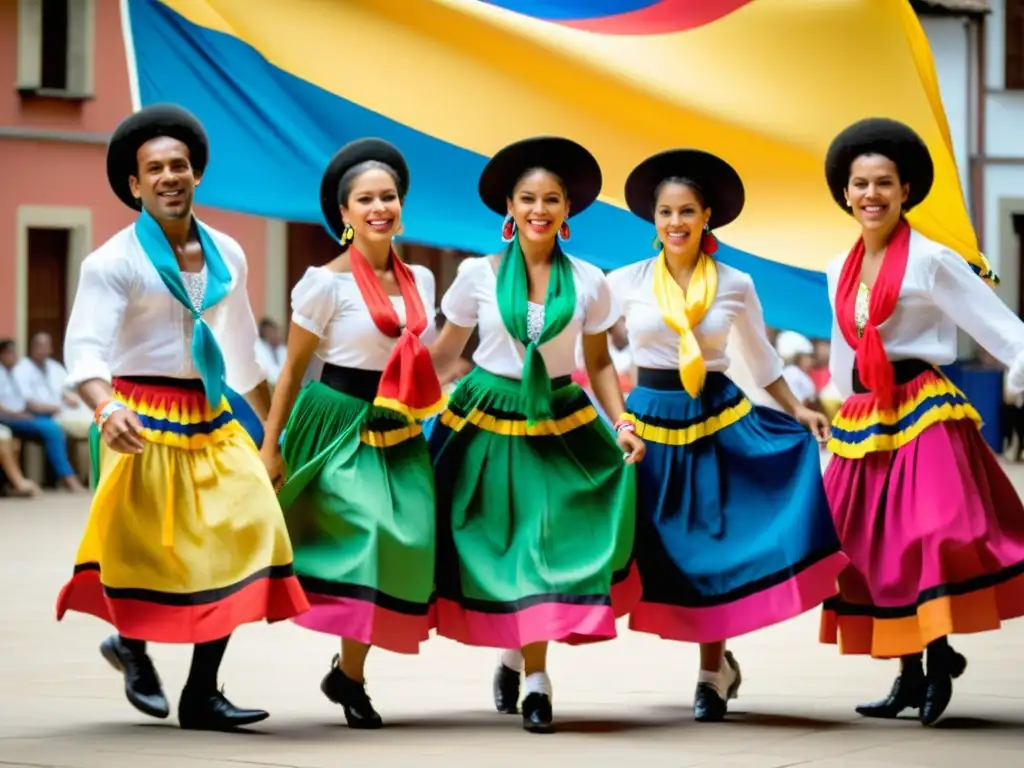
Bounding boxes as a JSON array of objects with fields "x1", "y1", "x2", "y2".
[{"x1": 478, "y1": 136, "x2": 602, "y2": 216}]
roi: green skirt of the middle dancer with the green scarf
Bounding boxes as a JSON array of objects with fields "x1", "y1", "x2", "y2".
[{"x1": 429, "y1": 368, "x2": 640, "y2": 648}]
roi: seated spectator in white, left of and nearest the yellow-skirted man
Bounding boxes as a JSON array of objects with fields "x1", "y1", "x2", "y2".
[{"x1": 13, "y1": 333, "x2": 93, "y2": 440}]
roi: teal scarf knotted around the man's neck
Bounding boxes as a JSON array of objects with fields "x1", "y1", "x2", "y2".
[{"x1": 135, "y1": 210, "x2": 231, "y2": 408}]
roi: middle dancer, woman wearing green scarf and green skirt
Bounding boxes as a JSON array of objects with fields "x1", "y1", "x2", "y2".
[{"x1": 430, "y1": 137, "x2": 644, "y2": 732}]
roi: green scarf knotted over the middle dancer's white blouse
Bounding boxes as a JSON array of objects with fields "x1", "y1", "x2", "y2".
[{"x1": 498, "y1": 238, "x2": 575, "y2": 426}]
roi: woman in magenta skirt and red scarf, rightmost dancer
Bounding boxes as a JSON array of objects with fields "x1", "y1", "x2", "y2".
[{"x1": 821, "y1": 119, "x2": 1024, "y2": 725}]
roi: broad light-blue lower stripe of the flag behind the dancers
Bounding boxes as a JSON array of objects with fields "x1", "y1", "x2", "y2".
[{"x1": 128, "y1": 0, "x2": 831, "y2": 338}]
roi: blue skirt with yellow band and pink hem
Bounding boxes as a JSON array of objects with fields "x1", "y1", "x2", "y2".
[{"x1": 626, "y1": 371, "x2": 847, "y2": 642}]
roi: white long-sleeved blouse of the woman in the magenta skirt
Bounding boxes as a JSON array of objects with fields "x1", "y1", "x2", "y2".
[{"x1": 826, "y1": 231, "x2": 1024, "y2": 397}]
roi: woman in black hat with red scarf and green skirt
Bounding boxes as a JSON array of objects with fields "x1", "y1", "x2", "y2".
[{"x1": 262, "y1": 139, "x2": 441, "y2": 728}]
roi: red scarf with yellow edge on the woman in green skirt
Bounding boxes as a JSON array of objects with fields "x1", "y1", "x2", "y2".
[{"x1": 348, "y1": 247, "x2": 442, "y2": 419}]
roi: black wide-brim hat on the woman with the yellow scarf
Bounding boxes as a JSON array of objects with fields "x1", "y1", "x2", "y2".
[{"x1": 626, "y1": 150, "x2": 746, "y2": 229}]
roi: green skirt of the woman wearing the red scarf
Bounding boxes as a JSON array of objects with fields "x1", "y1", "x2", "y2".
[{"x1": 279, "y1": 382, "x2": 435, "y2": 653}]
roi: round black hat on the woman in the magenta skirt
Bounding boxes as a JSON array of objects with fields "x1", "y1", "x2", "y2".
[{"x1": 825, "y1": 118, "x2": 935, "y2": 215}]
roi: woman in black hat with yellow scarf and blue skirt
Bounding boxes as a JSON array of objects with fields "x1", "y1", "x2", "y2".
[{"x1": 608, "y1": 150, "x2": 846, "y2": 721}]
